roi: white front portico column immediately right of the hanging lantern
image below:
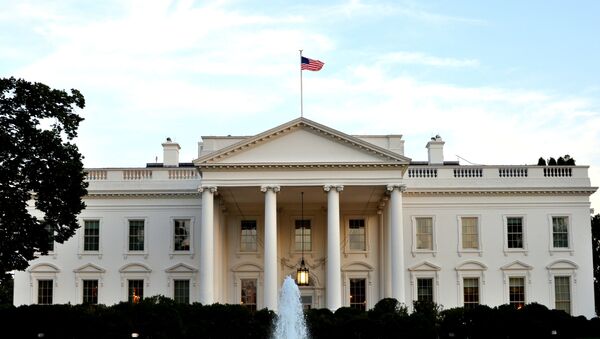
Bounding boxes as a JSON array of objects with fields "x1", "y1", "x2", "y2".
[{"x1": 323, "y1": 185, "x2": 344, "y2": 311}]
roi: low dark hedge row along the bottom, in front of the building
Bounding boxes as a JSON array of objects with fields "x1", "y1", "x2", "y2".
[{"x1": 0, "y1": 297, "x2": 600, "y2": 339}]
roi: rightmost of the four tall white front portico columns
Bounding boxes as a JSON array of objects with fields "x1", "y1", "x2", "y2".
[{"x1": 387, "y1": 184, "x2": 406, "y2": 303}]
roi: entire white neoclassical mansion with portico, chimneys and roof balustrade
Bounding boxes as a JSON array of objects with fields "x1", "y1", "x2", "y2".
[{"x1": 14, "y1": 118, "x2": 596, "y2": 317}]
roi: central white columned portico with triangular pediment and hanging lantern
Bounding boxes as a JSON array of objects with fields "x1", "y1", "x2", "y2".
[{"x1": 194, "y1": 118, "x2": 409, "y2": 310}]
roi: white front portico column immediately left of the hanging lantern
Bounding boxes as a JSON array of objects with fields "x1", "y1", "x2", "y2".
[{"x1": 260, "y1": 185, "x2": 279, "y2": 311}]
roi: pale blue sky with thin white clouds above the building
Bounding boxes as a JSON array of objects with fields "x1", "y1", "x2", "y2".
[{"x1": 0, "y1": 0, "x2": 600, "y2": 213}]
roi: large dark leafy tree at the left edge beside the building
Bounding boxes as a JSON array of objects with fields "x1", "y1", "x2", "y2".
[{"x1": 0, "y1": 77, "x2": 87, "y2": 277}]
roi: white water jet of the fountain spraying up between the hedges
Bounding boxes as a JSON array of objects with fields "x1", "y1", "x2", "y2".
[{"x1": 274, "y1": 275, "x2": 308, "y2": 339}]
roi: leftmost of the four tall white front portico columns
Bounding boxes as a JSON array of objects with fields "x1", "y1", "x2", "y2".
[{"x1": 198, "y1": 186, "x2": 217, "y2": 305}]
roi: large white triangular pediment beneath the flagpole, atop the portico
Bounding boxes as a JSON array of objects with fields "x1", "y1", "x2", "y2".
[{"x1": 194, "y1": 118, "x2": 410, "y2": 167}]
